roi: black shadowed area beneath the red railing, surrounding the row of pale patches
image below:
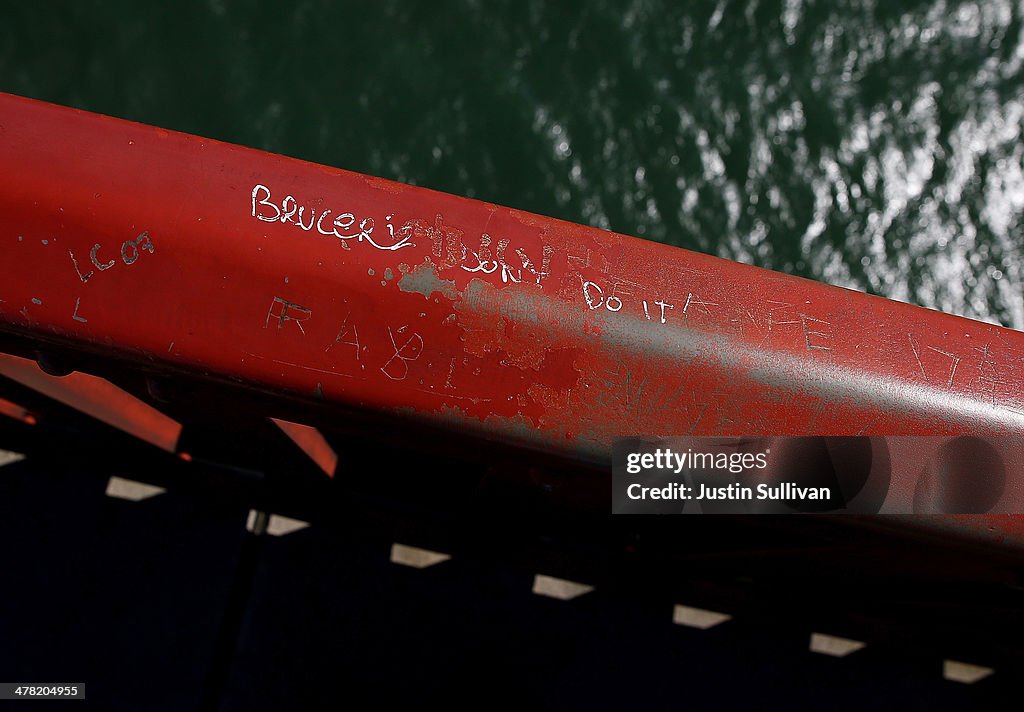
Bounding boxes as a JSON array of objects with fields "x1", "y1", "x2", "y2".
[{"x1": 0, "y1": 404, "x2": 1024, "y2": 710}]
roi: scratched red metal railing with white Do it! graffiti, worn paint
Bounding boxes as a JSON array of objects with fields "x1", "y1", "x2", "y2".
[{"x1": 0, "y1": 86, "x2": 1024, "y2": 520}]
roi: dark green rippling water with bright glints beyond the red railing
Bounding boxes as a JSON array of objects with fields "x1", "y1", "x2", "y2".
[{"x1": 0, "y1": 0, "x2": 1024, "y2": 329}]
